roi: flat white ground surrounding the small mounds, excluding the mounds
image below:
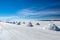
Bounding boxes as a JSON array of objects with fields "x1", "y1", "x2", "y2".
[{"x1": 0, "y1": 21, "x2": 60, "y2": 40}]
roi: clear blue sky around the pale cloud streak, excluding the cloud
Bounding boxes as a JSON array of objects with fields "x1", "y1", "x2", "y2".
[{"x1": 0, "y1": 0, "x2": 60, "y2": 19}]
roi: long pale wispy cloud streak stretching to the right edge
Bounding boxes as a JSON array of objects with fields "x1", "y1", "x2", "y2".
[{"x1": 17, "y1": 9, "x2": 60, "y2": 16}]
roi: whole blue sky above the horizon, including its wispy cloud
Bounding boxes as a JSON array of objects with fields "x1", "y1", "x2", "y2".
[{"x1": 0, "y1": 0, "x2": 60, "y2": 19}]
